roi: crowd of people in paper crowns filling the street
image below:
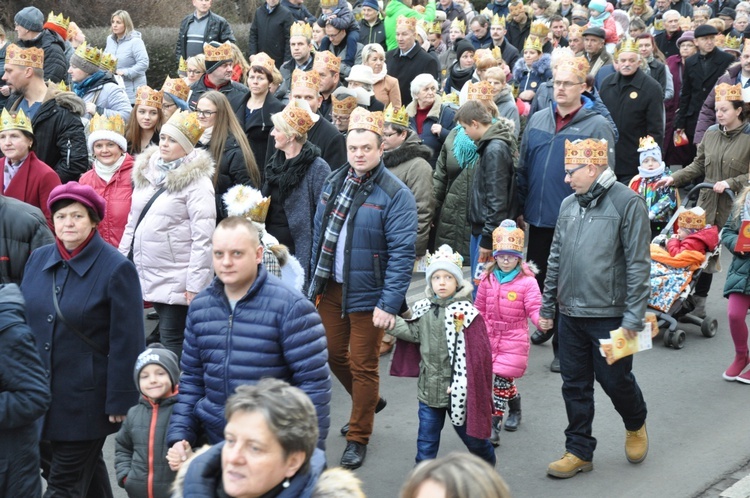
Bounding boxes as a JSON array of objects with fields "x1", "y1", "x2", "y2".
[{"x1": 0, "y1": 0, "x2": 750, "y2": 497}]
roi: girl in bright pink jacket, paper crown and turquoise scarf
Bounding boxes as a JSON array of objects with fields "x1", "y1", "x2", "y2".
[{"x1": 474, "y1": 220, "x2": 542, "y2": 446}]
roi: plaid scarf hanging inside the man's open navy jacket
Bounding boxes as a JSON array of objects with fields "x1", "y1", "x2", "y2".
[{"x1": 308, "y1": 168, "x2": 372, "y2": 305}]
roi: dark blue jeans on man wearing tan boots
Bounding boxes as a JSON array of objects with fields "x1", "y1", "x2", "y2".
[{"x1": 558, "y1": 313, "x2": 646, "y2": 461}]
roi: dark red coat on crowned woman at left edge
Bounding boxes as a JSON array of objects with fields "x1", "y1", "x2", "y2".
[{"x1": 0, "y1": 152, "x2": 60, "y2": 228}]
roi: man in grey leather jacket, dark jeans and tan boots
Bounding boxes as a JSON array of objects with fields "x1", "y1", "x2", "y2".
[{"x1": 540, "y1": 137, "x2": 651, "y2": 479}]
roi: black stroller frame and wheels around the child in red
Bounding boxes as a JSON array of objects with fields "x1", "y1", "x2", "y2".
[{"x1": 649, "y1": 182, "x2": 734, "y2": 349}]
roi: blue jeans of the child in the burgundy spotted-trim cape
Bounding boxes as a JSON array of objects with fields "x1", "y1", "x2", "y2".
[{"x1": 416, "y1": 401, "x2": 496, "y2": 467}]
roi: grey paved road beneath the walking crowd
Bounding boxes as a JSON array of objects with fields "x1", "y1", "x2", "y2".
[{"x1": 101, "y1": 249, "x2": 750, "y2": 498}]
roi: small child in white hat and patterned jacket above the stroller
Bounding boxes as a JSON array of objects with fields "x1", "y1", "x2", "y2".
[{"x1": 629, "y1": 135, "x2": 677, "y2": 239}]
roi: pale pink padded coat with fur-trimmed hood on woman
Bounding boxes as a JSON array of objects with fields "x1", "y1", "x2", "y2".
[{"x1": 119, "y1": 145, "x2": 216, "y2": 306}]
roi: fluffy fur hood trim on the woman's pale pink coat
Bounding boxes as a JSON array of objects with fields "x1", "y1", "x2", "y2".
[{"x1": 133, "y1": 145, "x2": 214, "y2": 192}]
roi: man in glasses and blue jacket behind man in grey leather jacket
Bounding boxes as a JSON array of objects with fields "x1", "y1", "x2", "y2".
[{"x1": 516, "y1": 56, "x2": 615, "y2": 372}]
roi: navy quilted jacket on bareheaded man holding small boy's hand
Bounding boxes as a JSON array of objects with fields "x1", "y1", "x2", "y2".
[{"x1": 167, "y1": 266, "x2": 331, "y2": 449}]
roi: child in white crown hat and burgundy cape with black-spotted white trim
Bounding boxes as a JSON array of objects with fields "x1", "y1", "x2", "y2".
[{"x1": 388, "y1": 244, "x2": 495, "y2": 466}]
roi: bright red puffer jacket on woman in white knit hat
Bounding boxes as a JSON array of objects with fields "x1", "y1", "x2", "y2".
[{"x1": 79, "y1": 153, "x2": 133, "y2": 247}]
